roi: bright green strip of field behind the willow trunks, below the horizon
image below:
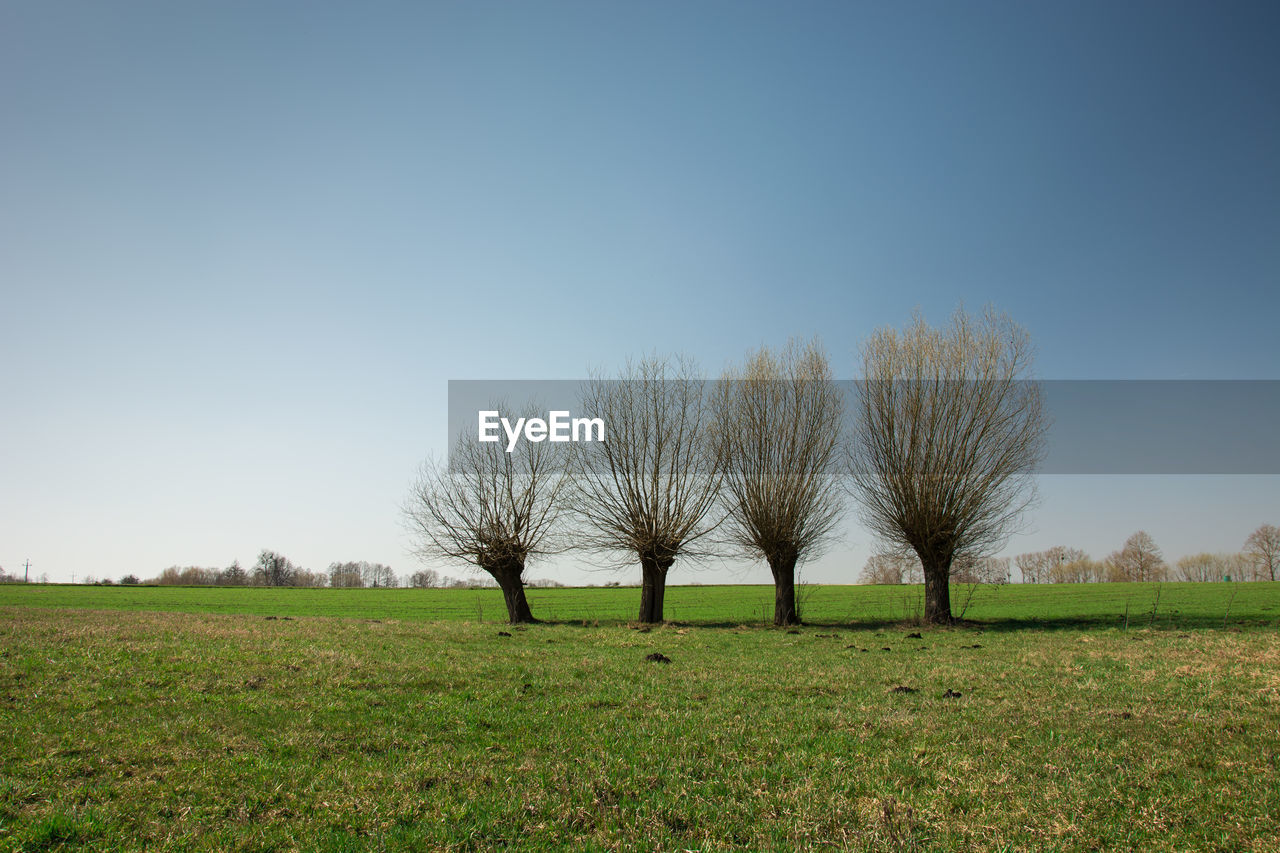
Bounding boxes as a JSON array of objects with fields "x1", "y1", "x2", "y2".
[{"x1": 0, "y1": 581, "x2": 1280, "y2": 628}]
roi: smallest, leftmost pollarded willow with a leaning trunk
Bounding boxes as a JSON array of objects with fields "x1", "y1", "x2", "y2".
[{"x1": 403, "y1": 406, "x2": 567, "y2": 622}]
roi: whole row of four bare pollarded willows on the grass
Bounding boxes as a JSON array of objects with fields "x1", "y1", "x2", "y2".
[{"x1": 404, "y1": 310, "x2": 1047, "y2": 625}]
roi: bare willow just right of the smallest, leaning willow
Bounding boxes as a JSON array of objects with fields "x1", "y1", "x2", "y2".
[{"x1": 573, "y1": 356, "x2": 722, "y2": 622}]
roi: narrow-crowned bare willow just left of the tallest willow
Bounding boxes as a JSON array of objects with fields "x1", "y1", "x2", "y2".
[{"x1": 713, "y1": 341, "x2": 845, "y2": 625}]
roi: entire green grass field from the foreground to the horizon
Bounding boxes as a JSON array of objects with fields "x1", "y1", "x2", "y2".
[{"x1": 0, "y1": 584, "x2": 1280, "y2": 850}]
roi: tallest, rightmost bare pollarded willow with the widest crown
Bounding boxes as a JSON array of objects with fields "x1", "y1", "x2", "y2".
[{"x1": 849, "y1": 309, "x2": 1047, "y2": 622}]
